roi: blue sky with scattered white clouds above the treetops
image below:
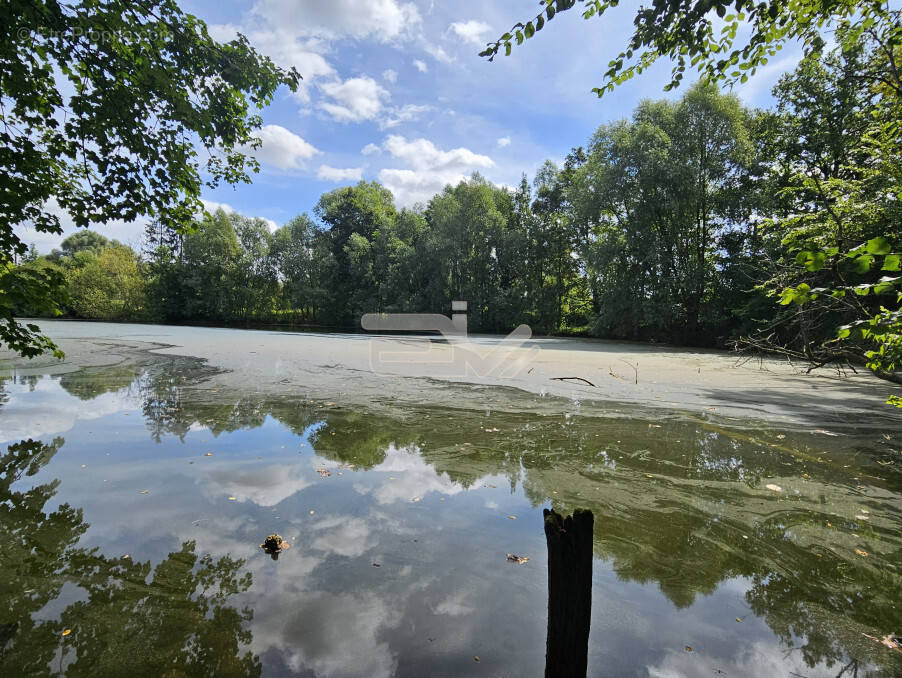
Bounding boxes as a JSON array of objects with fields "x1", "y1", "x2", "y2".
[{"x1": 19, "y1": 0, "x2": 800, "y2": 252}]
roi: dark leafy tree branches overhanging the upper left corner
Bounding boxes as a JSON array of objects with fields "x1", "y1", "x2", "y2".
[{"x1": 0, "y1": 0, "x2": 299, "y2": 356}]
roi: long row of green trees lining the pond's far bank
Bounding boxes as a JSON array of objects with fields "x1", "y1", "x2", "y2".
[{"x1": 10, "y1": 34, "x2": 902, "y2": 372}]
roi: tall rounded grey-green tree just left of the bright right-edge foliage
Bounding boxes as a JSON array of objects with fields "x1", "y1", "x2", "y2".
[{"x1": 574, "y1": 84, "x2": 752, "y2": 343}]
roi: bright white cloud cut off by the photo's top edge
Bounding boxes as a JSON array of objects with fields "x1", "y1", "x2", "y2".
[{"x1": 252, "y1": 0, "x2": 420, "y2": 42}]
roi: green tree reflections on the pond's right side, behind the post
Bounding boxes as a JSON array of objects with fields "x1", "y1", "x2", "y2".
[{"x1": 49, "y1": 361, "x2": 902, "y2": 673}]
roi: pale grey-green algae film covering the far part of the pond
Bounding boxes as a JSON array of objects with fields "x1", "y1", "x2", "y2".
[{"x1": 0, "y1": 320, "x2": 902, "y2": 430}]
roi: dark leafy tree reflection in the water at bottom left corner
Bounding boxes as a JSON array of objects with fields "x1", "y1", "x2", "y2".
[{"x1": 0, "y1": 438, "x2": 261, "y2": 676}]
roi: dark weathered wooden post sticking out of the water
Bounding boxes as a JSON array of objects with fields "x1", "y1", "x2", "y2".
[{"x1": 543, "y1": 509, "x2": 595, "y2": 678}]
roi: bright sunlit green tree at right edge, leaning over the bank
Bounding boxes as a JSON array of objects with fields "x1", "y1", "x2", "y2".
[{"x1": 747, "y1": 27, "x2": 902, "y2": 398}]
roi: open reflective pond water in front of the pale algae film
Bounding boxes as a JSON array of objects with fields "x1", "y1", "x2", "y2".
[{"x1": 0, "y1": 353, "x2": 902, "y2": 677}]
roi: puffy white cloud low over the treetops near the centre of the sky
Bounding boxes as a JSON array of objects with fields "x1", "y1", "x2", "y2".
[{"x1": 379, "y1": 134, "x2": 495, "y2": 205}]
